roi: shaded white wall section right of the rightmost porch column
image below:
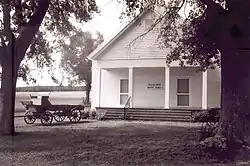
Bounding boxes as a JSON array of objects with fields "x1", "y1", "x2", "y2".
[{"x1": 207, "y1": 68, "x2": 221, "y2": 108}]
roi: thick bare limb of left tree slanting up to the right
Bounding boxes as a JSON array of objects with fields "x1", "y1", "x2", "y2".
[{"x1": 16, "y1": 0, "x2": 50, "y2": 63}]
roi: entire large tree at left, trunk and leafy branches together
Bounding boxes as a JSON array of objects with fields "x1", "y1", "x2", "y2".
[{"x1": 0, "y1": 0, "x2": 99, "y2": 135}]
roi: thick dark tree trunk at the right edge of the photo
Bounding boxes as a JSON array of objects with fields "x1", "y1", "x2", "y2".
[{"x1": 217, "y1": 49, "x2": 250, "y2": 145}]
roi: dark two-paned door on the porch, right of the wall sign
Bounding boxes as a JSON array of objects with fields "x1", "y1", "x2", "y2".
[{"x1": 177, "y1": 79, "x2": 189, "y2": 106}]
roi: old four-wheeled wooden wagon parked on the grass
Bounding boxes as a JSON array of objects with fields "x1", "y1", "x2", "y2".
[{"x1": 21, "y1": 96, "x2": 84, "y2": 125}]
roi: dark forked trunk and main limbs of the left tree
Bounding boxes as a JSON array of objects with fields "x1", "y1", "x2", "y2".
[{"x1": 0, "y1": 0, "x2": 50, "y2": 135}]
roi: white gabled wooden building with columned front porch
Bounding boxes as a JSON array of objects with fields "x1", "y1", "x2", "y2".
[{"x1": 89, "y1": 10, "x2": 221, "y2": 109}]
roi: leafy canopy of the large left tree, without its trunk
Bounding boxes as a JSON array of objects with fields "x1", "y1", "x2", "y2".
[{"x1": 0, "y1": 0, "x2": 99, "y2": 82}]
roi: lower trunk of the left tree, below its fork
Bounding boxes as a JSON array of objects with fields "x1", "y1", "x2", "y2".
[{"x1": 0, "y1": 41, "x2": 20, "y2": 135}]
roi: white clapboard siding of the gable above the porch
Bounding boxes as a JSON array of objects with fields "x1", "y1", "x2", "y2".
[{"x1": 99, "y1": 11, "x2": 168, "y2": 60}]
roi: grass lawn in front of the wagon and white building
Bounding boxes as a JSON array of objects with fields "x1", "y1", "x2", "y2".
[{"x1": 0, "y1": 118, "x2": 250, "y2": 166}]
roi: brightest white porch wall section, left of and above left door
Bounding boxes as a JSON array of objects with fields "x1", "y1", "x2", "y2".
[{"x1": 99, "y1": 69, "x2": 128, "y2": 107}]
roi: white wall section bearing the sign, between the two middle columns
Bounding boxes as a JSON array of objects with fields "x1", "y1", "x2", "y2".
[{"x1": 133, "y1": 68, "x2": 165, "y2": 108}]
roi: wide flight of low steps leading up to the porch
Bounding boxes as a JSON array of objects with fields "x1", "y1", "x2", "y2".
[{"x1": 97, "y1": 108, "x2": 192, "y2": 122}]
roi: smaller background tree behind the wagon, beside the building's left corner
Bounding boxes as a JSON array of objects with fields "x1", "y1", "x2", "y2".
[{"x1": 61, "y1": 31, "x2": 104, "y2": 104}]
